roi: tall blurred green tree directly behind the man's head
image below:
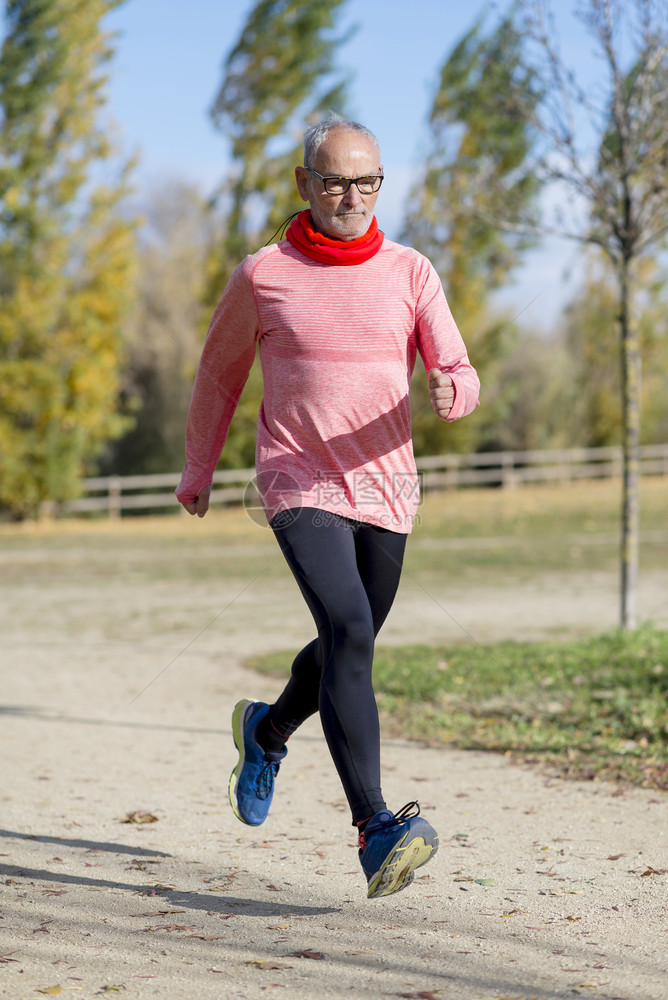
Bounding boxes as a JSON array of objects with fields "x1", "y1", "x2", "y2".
[{"x1": 211, "y1": 0, "x2": 352, "y2": 298}]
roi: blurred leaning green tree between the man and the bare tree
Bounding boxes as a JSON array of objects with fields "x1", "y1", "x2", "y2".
[{"x1": 402, "y1": 8, "x2": 539, "y2": 451}]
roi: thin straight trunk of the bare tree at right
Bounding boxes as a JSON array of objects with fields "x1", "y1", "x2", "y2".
[{"x1": 619, "y1": 259, "x2": 642, "y2": 629}]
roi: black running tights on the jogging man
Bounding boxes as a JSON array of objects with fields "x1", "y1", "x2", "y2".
[{"x1": 269, "y1": 508, "x2": 406, "y2": 824}]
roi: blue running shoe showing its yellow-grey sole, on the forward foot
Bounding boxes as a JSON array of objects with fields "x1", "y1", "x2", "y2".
[{"x1": 359, "y1": 802, "x2": 438, "y2": 899}]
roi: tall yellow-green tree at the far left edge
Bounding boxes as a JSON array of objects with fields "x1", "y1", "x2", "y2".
[{"x1": 0, "y1": 0, "x2": 134, "y2": 517}]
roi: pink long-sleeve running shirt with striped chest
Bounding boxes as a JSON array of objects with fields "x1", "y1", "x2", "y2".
[{"x1": 176, "y1": 234, "x2": 479, "y2": 533}]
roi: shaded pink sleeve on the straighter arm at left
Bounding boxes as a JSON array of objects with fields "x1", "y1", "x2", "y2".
[{"x1": 176, "y1": 257, "x2": 260, "y2": 503}]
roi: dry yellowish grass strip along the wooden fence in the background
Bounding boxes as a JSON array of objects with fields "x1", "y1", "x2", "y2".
[{"x1": 5, "y1": 476, "x2": 668, "y2": 585}]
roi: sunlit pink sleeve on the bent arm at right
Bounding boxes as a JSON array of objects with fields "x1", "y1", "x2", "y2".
[{"x1": 415, "y1": 257, "x2": 480, "y2": 423}]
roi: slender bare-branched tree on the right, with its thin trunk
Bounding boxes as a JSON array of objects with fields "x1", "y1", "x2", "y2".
[{"x1": 506, "y1": 0, "x2": 668, "y2": 629}]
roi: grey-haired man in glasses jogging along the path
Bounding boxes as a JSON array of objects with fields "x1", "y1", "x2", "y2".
[{"x1": 177, "y1": 115, "x2": 479, "y2": 897}]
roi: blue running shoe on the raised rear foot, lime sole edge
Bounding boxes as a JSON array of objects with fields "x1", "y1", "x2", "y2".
[{"x1": 229, "y1": 698, "x2": 288, "y2": 826}]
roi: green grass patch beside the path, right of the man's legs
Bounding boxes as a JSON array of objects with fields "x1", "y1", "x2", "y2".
[{"x1": 250, "y1": 626, "x2": 668, "y2": 790}]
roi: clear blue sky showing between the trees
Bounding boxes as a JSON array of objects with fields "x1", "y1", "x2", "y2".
[{"x1": 106, "y1": 0, "x2": 592, "y2": 323}]
